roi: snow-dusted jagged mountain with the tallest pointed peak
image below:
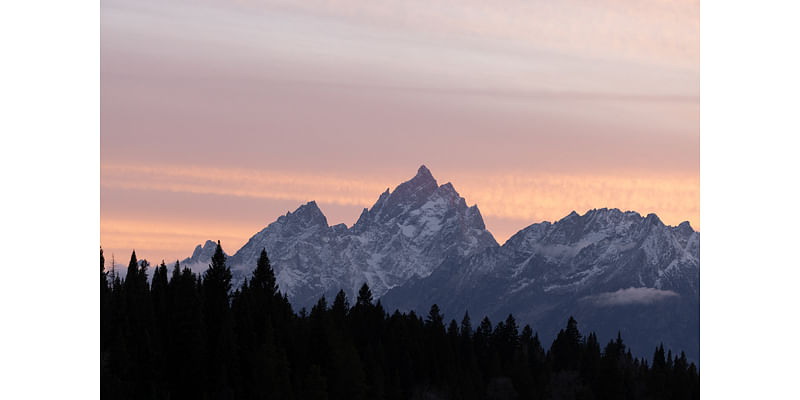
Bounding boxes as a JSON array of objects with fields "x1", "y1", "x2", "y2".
[{"x1": 209, "y1": 166, "x2": 498, "y2": 306}]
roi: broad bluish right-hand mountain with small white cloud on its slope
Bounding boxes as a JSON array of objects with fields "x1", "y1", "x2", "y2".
[{"x1": 382, "y1": 209, "x2": 700, "y2": 362}]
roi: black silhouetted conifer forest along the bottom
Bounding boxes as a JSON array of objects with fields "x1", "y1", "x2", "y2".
[{"x1": 100, "y1": 244, "x2": 700, "y2": 400}]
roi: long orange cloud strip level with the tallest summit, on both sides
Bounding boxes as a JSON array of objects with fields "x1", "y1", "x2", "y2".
[{"x1": 100, "y1": 164, "x2": 699, "y2": 231}]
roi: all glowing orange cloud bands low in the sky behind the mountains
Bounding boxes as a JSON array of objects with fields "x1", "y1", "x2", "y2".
[{"x1": 100, "y1": 164, "x2": 700, "y2": 259}]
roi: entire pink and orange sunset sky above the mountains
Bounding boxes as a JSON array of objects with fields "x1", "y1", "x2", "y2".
[{"x1": 100, "y1": 0, "x2": 700, "y2": 261}]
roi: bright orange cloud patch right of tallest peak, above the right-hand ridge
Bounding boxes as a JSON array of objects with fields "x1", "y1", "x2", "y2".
[{"x1": 454, "y1": 173, "x2": 700, "y2": 228}]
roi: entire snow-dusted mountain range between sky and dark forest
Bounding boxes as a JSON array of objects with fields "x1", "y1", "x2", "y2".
[{"x1": 181, "y1": 165, "x2": 700, "y2": 363}]
